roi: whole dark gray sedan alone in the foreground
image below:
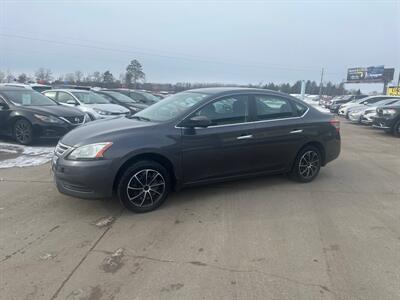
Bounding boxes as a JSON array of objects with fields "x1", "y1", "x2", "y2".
[{"x1": 52, "y1": 88, "x2": 340, "y2": 212}]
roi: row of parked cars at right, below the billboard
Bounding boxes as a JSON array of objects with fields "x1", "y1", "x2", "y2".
[{"x1": 319, "y1": 95, "x2": 400, "y2": 137}]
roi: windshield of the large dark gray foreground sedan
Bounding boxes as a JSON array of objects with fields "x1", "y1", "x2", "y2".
[{"x1": 133, "y1": 92, "x2": 208, "y2": 122}]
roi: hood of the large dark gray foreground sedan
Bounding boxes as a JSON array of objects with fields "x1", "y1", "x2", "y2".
[{"x1": 61, "y1": 118, "x2": 157, "y2": 146}]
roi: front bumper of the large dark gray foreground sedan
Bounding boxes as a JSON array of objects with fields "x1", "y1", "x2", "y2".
[{"x1": 51, "y1": 155, "x2": 115, "y2": 199}]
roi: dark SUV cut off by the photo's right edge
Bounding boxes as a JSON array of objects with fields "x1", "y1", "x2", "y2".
[{"x1": 372, "y1": 105, "x2": 400, "y2": 137}]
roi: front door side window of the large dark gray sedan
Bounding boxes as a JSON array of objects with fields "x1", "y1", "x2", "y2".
[{"x1": 196, "y1": 95, "x2": 249, "y2": 125}]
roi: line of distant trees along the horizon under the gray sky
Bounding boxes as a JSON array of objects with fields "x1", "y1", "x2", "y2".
[{"x1": 0, "y1": 59, "x2": 360, "y2": 96}]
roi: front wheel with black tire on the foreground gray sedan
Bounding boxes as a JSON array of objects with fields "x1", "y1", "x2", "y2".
[{"x1": 117, "y1": 160, "x2": 171, "y2": 213}]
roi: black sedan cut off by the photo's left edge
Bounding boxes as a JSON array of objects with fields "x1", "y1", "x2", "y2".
[{"x1": 0, "y1": 87, "x2": 86, "y2": 145}]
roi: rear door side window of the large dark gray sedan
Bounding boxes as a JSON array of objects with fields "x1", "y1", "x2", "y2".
[{"x1": 255, "y1": 95, "x2": 296, "y2": 120}]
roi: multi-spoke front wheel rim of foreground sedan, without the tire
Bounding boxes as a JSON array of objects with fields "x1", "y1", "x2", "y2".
[{"x1": 126, "y1": 169, "x2": 165, "y2": 207}]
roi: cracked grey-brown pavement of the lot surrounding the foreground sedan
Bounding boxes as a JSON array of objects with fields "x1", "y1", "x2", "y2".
[{"x1": 0, "y1": 122, "x2": 400, "y2": 300}]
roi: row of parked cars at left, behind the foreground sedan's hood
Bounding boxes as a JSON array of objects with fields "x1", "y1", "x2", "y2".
[{"x1": 0, "y1": 84, "x2": 160, "y2": 145}]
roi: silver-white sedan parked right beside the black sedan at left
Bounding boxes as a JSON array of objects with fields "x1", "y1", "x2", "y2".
[{"x1": 43, "y1": 89, "x2": 130, "y2": 120}]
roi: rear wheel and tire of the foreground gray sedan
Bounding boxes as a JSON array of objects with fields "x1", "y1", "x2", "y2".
[{"x1": 290, "y1": 146, "x2": 322, "y2": 183}]
